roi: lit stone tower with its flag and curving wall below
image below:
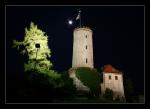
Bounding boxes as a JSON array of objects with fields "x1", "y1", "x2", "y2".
[{"x1": 69, "y1": 11, "x2": 94, "y2": 93}]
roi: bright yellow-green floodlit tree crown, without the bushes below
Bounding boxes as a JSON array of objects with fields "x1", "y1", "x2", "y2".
[{"x1": 13, "y1": 22, "x2": 52, "y2": 71}]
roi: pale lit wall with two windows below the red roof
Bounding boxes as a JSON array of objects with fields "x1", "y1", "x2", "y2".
[{"x1": 101, "y1": 72, "x2": 124, "y2": 98}]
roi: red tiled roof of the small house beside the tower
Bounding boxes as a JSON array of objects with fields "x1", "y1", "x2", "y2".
[{"x1": 102, "y1": 64, "x2": 121, "y2": 74}]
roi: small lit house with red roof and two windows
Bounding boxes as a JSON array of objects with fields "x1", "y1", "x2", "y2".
[{"x1": 101, "y1": 65, "x2": 124, "y2": 98}]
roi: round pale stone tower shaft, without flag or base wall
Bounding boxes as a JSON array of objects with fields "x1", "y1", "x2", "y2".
[{"x1": 72, "y1": 27, "x2": 94, "y2": 68}]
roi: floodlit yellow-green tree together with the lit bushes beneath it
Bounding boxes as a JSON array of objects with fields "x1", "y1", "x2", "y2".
[{"x1": 13, "y1": 22, "x2": 60, "y2": 78}]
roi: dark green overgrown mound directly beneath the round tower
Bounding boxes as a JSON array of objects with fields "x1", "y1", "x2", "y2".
[{"x1": 76, "y1": 67, "x2": 100, "y2": 96}]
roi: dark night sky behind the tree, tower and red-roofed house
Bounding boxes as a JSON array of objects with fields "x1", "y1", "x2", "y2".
[{"x1": 6, "y1": 6, "x2": 144, "y2": 93}]
